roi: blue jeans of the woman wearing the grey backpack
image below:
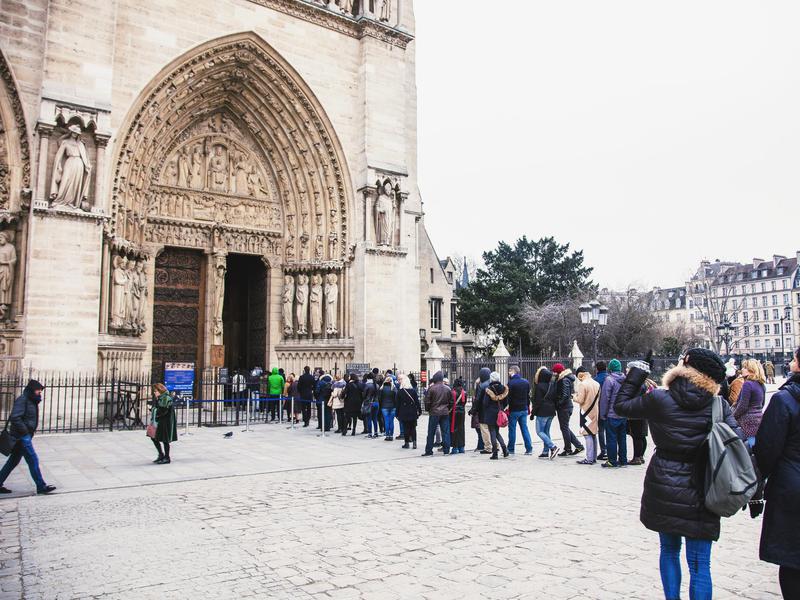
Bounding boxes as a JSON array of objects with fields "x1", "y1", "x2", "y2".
[{"x1": 658, "y1": 533, "x2": 711, "y2": 600}]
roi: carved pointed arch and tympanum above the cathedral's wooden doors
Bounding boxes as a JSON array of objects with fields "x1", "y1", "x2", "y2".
[{"x1": 107, "y1": 33, "x2": 351, "y2": 262}]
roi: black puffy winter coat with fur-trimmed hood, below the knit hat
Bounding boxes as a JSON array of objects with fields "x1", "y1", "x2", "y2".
[{"x1": 620, "y1": 365, "x2": 744, "y2": 540}]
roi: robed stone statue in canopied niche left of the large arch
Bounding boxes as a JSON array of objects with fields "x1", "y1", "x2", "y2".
[{"x1": 50, "y1": 125, "x2": 92, "y2": 210}]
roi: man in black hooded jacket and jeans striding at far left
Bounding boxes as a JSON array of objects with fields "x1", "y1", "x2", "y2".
[{"x1": 0, "y1": 379, "x2": 56, "y2": 494}]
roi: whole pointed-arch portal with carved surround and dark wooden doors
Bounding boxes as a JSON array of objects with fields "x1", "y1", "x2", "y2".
[{"x1": 101, "y1": 33, "x2": 352, "y2": 376}]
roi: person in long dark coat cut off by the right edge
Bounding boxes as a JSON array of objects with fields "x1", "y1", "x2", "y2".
[{"x1": 755, "y1": 348, "x2": 800, "y2": 598}]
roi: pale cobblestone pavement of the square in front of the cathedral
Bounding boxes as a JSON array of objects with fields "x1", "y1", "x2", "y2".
[{"x1": 0, "y1": 419, "x2": 779, "y2": 600}]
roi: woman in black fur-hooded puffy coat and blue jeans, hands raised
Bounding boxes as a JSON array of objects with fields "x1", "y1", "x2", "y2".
[{"x1": 604, "y1": 348, "x2": 744, "y2": 600}]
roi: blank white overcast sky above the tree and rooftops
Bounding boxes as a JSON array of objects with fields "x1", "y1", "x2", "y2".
[{"x1": 414, "y1": 0, "x2": 800, "y2": 288}]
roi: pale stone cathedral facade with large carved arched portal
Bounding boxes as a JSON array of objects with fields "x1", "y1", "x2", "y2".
[{"x1": 0, "y1": 0, "x2": 424, "y2": 373}]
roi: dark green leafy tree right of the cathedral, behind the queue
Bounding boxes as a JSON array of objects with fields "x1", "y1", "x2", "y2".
[{"x1": 458, "y1": 236, "x2": 595, "y2": 352}]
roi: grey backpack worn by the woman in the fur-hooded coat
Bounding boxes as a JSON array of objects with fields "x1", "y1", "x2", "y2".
[{"x1": 705, "y1": 396, "x2": 759, "y2": 517}]
